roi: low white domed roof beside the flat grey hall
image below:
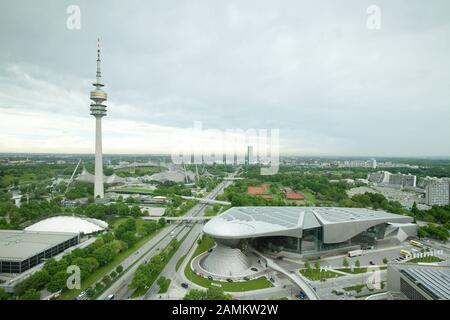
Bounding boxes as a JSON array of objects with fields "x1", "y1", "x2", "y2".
[{"x1": 25, "y1": 216, "x2": 108, "y2": 234}]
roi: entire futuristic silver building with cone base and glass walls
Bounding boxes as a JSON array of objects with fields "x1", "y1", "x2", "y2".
[{"x1": 196, "y1": 207, "x2": 417, "y2": 277}]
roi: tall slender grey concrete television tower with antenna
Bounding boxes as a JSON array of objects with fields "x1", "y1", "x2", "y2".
[{"x1": 91, "y1": 39, "x2": 108, "y2": 198}]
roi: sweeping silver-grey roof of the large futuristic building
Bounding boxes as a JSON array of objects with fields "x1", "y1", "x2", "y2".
[{"x1": 203, "y1": 207, "x2": 413, "y2": 243}]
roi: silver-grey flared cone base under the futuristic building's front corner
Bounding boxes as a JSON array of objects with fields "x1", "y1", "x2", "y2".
[{"x1": 200, "y1": 244, "x2": 251, "y2": 277}]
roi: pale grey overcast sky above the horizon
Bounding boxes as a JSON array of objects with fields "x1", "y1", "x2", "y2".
[{"x1": 0, "y1": 0, "x2": 450, "y2": 156}]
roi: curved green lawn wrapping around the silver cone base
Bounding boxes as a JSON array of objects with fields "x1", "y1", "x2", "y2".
[{"x1": 184, "y1": 236, "x2": 273, "y2": 292}]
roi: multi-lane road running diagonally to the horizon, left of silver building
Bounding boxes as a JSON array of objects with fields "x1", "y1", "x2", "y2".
[{"x1": 97, "y1": 170, "x2": 237, "y2": 300}]
